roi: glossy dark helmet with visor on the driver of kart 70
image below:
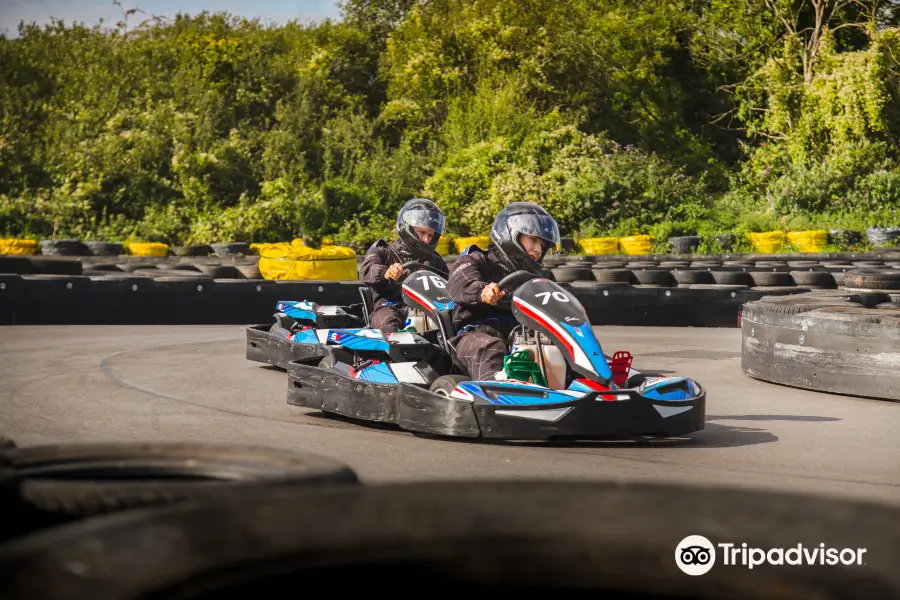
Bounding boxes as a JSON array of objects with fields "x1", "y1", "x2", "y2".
[{"x1": 491, "y1": 202, "x2": 560, "y2": 273}]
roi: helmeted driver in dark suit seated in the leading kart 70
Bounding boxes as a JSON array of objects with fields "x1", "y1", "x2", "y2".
[{"x1": 449, "y1": 202, "x2": 560, "y2": 381}]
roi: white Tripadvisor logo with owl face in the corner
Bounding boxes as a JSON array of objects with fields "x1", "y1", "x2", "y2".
[{"x1": 675, "y1": 535, "x2": 866, "y2": 575}]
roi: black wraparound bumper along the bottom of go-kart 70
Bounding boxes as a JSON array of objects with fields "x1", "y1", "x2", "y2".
[{"x1": 287, "y1": 361, "x2": 706, "y2": 440}]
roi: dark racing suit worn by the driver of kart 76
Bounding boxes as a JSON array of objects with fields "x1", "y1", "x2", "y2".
[{"x1": 359, "y1": 240, "x2": 449, "y2": 333}]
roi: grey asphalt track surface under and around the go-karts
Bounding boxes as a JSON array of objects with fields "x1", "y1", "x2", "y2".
[{"x1": 0, "y1": 326, "x2": 900, "y2": 504}]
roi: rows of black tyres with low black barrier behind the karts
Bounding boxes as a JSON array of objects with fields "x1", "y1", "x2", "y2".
[{"x1": 0, "y1": 252, "x2": 900, "y2": 327}]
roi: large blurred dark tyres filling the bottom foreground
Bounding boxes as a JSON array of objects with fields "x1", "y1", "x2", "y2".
[{"x1": 0, "y1": 444, "x2": 900, "y2": 600}]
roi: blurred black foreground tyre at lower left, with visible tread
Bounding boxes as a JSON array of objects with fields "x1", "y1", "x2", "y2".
[{"x1": 0, "y1": 443, "x2": 359, "y2": 538}]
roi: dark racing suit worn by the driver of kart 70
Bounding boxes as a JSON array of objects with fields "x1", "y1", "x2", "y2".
[{"x1": 449, "y1": 246, "x2": 516, "y2": 381}]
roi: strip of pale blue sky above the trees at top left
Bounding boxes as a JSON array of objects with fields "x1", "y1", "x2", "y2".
[{"x1": 0, "y1": 0, "x2": 340, "y2": 38}]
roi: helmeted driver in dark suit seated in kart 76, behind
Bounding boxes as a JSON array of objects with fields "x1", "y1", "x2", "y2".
[{"x1": 359, "y1": 198, "x2": 449, "y2": 333}]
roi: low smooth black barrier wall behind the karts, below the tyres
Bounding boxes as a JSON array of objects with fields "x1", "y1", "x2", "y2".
[{"x1": 0, "y1": 269, "x2": 808, "y2": 327}]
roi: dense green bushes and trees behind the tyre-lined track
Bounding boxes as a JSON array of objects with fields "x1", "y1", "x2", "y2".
[{"x1": 0, "y1": 0, "x2": 900, "y2": 249}]
